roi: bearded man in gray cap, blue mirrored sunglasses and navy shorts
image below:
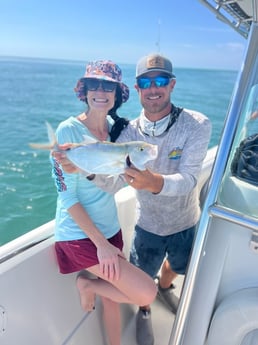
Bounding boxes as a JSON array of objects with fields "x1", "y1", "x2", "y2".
[{"x1": 54, "y1": 54, "x2": 211, "y2": 345}]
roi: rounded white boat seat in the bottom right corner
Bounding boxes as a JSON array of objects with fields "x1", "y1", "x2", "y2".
[{"x1": 205, "y1": 287, "x2": 258, "y2": 345}]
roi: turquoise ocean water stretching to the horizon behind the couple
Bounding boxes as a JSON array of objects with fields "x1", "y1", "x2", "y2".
[{"x1": 0, "y1": 57, "x2": 237, "y2": 245}]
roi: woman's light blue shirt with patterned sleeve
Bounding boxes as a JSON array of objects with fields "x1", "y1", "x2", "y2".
[{"x1": 51, "y1": 117, "x2": 120, "y2": 241}]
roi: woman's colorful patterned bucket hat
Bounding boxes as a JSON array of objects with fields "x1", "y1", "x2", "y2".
[{"x1": 74, "y1": 60, "x2": 129, "y2": 103}]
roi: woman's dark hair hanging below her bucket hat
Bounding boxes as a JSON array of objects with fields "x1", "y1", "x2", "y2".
[{"x1": 84, "y1": 84, "x2": 129, "y2": 142}]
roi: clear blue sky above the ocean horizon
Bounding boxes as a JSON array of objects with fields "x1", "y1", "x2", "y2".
[{"x1": 0, "y1": 0, "x2": 249, "y2": 70}]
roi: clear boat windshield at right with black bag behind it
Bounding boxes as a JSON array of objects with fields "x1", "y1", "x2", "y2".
[{"x1": 218, "y1": 80, "x2": 258, "y2": 218}]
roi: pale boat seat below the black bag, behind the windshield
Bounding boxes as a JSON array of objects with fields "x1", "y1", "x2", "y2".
[{"x1": 220, "y1": 176, "x2": 258, "y2": 217}]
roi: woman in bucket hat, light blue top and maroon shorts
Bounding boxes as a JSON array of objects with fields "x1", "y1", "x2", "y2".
[{"x1": 52, "y1": 60, "x2": 156, "y2": 345}]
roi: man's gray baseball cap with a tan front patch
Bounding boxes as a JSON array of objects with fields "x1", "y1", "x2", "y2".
[{"x1": 136, "y1": 54, "x2": 176, "y2": 78}]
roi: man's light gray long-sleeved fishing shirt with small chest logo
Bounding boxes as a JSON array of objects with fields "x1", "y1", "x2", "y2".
[{"x1": 94, "y1": 109, "x2": 211, "y2": 236}]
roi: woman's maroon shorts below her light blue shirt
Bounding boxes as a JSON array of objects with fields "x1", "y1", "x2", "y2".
[{"x1": 55, "y1": 230, "x2": 123, "y2": 274}]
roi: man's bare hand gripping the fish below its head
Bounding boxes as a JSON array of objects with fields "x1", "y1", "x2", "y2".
[{"x1": 124, "y1": 168, "x2": 164, "y2": 194}]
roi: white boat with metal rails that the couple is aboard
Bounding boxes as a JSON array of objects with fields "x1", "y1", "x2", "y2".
[{"x1": 0, "y1": 0, "x2": 258, "y2": 345}]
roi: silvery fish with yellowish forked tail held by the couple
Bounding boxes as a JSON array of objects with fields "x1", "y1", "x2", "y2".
[{"x1": 29, "y1": 122, "x2": 158, "y2": 176}]
